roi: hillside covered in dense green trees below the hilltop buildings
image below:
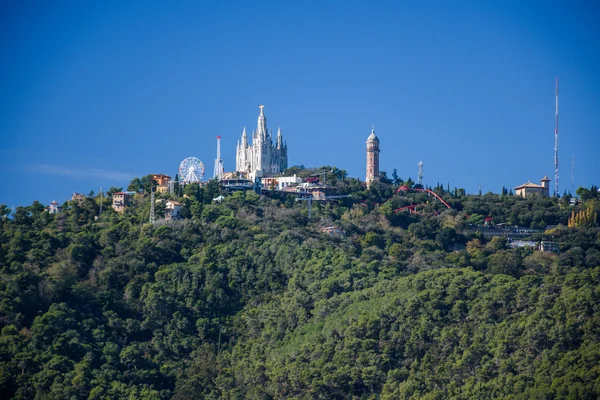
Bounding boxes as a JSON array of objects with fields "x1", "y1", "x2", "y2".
[{"x1": 0, "y1": 175, "x2": 600, "y2": 400}]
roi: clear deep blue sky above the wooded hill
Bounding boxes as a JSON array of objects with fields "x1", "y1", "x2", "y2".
[{"x1": 0, "y1": 0, "x2": 600, "y2": 206}]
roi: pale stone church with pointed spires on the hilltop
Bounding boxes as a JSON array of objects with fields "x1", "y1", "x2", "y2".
[{"x1": 235, "y1": 105, "x2": 288, "y2": 178}]
